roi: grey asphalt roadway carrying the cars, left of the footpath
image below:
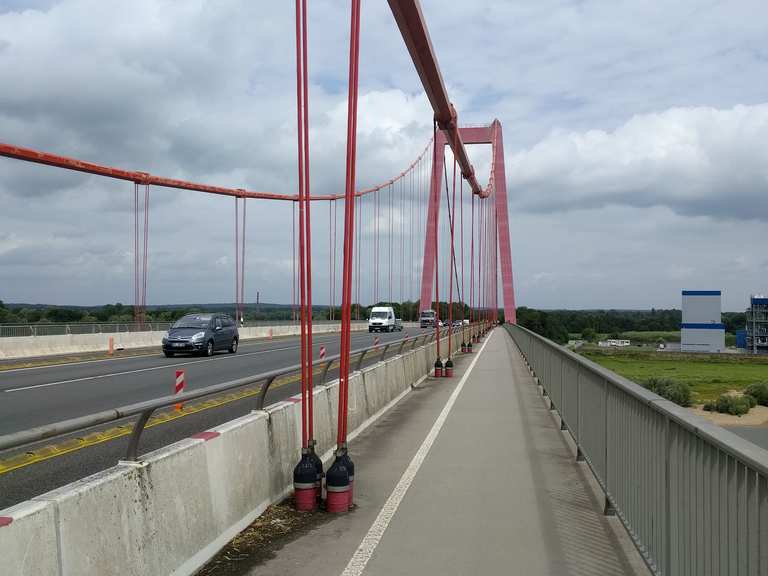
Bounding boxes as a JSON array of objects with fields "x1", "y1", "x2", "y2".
[{"x1": 0, "y1": 329, "x2": 432, "y2": 510}]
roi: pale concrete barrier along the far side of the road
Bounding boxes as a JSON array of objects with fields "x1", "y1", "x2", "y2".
[{"x1": 0, "y1": 322, "x2": 418, "y2": 360}]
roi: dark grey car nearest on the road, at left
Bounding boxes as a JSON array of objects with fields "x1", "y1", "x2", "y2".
[{"x1": 163, "y1": 314, "x2": 240, "y2": 358}]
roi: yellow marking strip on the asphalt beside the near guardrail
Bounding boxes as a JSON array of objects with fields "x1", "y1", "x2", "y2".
[{"x1": 0, "y1": 361, "x2": 352, "y2": 475}]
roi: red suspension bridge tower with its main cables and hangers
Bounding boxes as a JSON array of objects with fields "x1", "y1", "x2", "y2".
[{"x1": 0, "y1": 0, "x2": 515, "y2": 510}]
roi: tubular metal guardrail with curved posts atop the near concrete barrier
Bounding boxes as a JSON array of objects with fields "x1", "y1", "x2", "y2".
[{"x1": 0, "y1": 326, "x2": 479, "y2": 460}]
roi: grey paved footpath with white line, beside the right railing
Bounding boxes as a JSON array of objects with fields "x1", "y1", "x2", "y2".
[{"x1": 244, "y1": 329, "x2": 648, "y2": 576}]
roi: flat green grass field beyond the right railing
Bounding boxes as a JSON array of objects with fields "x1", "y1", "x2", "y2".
[{"x1": 580, "y1": 349, "x2": 768, "y2": 404}]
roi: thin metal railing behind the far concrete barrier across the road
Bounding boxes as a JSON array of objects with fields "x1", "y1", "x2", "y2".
[{"x1": 0, "y1": 320, "x2": 367, "y2": 338}]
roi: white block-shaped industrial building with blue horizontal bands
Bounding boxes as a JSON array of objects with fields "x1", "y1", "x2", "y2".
[{"x1": 680, "y1": 290, "x2": 725, "y2": 352}]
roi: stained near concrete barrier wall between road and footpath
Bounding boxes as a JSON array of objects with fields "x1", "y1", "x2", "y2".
[{"x1": 0, "y1": 328, "x2": 460, "y2": 576}]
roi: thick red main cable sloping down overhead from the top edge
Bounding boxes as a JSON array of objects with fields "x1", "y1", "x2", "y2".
[{"x1": 389, "y1": 0, "x2": 490, "y2": 198}]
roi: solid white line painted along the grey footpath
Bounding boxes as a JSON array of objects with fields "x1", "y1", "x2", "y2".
[{"x1": 341, "y1": 330, "x2": 490, "y2": 576}]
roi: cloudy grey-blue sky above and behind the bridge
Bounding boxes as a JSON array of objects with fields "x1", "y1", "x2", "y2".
[{"x1": 0, "y1": 0, "x2": 768, "y2": 310}]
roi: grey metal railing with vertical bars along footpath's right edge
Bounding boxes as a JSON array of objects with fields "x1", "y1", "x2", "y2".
[{"x1": 506, "y1": 325, "x2": 768, "y2": 576}]
